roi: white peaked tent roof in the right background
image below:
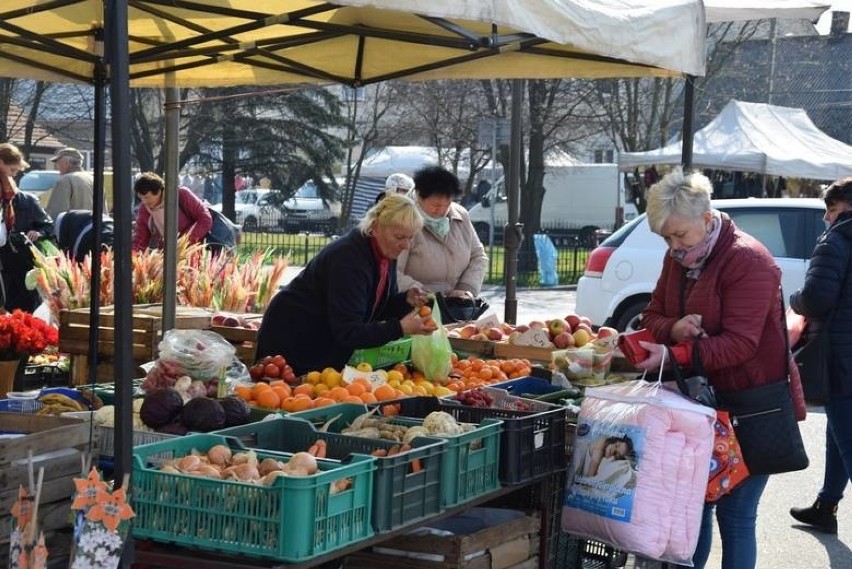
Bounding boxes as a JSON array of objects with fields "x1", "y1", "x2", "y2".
[{"x1": 618, "y1": 100, "x2": 852, "y2": 180}]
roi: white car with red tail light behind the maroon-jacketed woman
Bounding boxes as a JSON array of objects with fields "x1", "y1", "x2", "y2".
[{"x1": 576, "y1": 198, "x2": 826, "y2": 331}]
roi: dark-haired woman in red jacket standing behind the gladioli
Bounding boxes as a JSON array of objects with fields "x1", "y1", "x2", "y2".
[{"x1": 133, "y1": 172, "x2": 213, "y2": 251}]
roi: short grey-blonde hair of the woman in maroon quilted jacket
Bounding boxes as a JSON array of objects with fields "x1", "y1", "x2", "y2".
[{"x1": 645, "y1": 167, "x2": 713, "y2": 233}]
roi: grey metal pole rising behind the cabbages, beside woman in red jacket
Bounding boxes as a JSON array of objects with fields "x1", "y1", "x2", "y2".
[{"x1": 163, "y1": 86, "x2": 180, "y2": 332}]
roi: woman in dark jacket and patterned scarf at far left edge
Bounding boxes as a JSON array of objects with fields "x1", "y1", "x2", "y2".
[{"x1": 0, "y1": 143, "x2": 53, "y2": 312}]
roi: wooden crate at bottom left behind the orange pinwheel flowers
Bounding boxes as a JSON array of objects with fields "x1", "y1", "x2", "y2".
[{"x1": 0, "y1": 413, "x2": 99, "y2": 543}]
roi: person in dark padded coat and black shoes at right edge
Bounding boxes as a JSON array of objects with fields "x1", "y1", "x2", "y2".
[{"x1": 790, "y1": 177, "x2": 852, "y2": 534}]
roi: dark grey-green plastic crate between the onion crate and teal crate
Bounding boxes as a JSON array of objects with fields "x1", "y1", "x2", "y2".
[{"x1": 215, "y1": 416, "x2": 447, "y2": 532}]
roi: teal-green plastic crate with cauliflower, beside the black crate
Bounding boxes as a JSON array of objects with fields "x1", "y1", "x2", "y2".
[{"x1": 290, "y1": 403, "x2": 503, "y2": 508}]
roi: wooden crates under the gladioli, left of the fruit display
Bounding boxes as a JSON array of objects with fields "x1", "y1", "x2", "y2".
[{"x1": 59, "y1": 304, "x2": 211, "y2": 385}]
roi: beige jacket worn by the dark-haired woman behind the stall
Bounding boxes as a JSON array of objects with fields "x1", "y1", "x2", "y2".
[{"x1": 396, "y1": 203, "x2": 488, "y2": 296}]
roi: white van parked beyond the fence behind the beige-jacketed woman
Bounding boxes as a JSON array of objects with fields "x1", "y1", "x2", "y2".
[{"x1": 470, "y1": 164, "x2": 638, "y2": 243}]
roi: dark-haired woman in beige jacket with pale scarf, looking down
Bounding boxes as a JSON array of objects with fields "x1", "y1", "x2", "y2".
[{"x1": 397, "y1": 166, "x2": 488, "y2": 320}]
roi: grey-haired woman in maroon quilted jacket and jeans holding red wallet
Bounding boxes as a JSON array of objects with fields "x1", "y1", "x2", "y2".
[{"x1": 639, "y1": 168, "x2": 788, "y2": 569}]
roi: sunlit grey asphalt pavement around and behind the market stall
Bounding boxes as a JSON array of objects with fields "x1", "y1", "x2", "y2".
[{"x1": 285, "y1": 267, "x2": 852, "y2": 569}]
